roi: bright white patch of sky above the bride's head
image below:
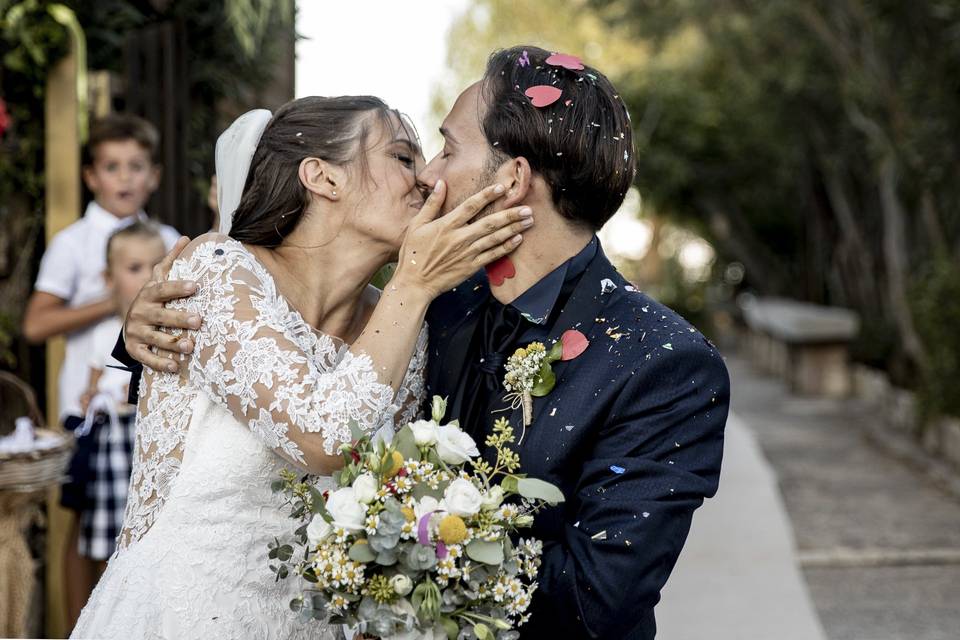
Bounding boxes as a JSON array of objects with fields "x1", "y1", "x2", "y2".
[{"x1": 296, "y1": 0, "x2": 469, "y2": 159}]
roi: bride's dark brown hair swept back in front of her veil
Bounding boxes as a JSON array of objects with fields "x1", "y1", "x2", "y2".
[{"x1": 230, "y1": 96, "x2": 405, "y2": 247}]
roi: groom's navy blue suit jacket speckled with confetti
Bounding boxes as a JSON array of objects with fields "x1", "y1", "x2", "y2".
[{"x1": 427, "y1": 244, "x2": 730, "y2": 640}]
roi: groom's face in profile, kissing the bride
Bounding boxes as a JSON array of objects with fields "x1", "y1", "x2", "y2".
[{"x1": 417, "y1": 82, "x2": 498, "y2": 215}]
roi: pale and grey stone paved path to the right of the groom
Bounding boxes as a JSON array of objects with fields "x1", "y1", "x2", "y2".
[{"x1": 658, "y1": 357, "x2": 960, "y2": 640}]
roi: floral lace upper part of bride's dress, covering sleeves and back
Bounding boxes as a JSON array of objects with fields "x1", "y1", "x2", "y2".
[{"x1": 117, "y1": 234, "x2": 427, "y2": 554}]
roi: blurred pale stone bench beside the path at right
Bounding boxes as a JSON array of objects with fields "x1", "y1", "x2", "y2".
[{"x1": 740, "y1": 297, "x2": 860, "y2": 398}]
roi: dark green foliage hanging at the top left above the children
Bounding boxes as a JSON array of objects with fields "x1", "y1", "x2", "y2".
[{"x1": 0, "y1": 0, "x2": 294, "y2": 370}]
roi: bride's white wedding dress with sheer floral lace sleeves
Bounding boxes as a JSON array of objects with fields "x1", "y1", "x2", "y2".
[{"x1": 71, "y1": 235, "x2": 426, "y2": 640}]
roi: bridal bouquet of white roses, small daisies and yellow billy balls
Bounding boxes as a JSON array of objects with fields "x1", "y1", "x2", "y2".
[{"x1": 270, "y1": 397, "x2": 563, "y2": 640}]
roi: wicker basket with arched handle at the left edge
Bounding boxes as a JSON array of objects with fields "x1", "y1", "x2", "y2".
[{"x1": 0, "y1": 371, "x2": 74, "y2": 491}]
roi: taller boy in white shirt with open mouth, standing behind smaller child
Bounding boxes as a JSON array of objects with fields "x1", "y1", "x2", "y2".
[{"x1": 23, "y1": 115, "x2": 179, "y2": 621}]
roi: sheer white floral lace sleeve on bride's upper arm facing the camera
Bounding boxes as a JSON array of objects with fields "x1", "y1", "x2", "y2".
[{"x1": 170, "y1": 236, "x2": 394, "y2": 468}]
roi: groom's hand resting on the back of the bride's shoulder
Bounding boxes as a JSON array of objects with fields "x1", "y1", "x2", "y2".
[{"x1": 123, "y1": 238, "x2": 200, "y2": 373}]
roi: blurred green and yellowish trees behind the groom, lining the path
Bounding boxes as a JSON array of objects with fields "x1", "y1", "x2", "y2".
[{"x1": 437, "y1": 0, "x2": 960, "y2": 420}]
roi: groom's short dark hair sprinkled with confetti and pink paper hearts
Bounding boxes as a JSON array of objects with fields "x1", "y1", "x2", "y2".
[{"x1": 481, "y1": 45, "x2": 636, "y2": 230}]
